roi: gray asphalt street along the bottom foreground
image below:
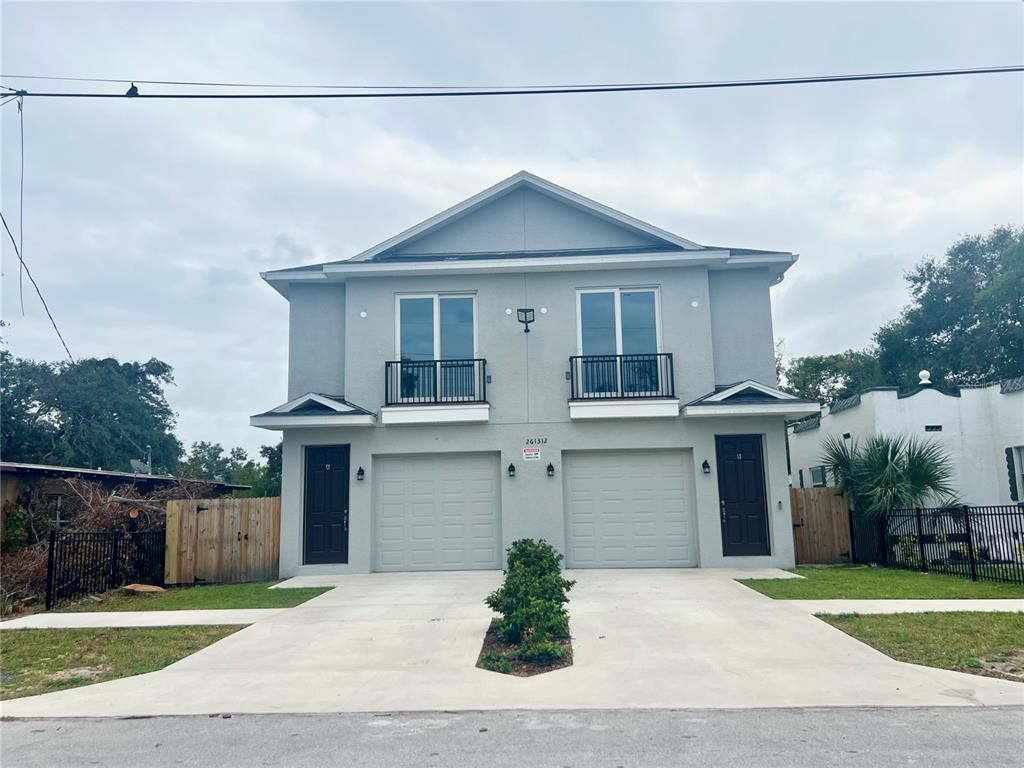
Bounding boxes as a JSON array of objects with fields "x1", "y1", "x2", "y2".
[{"x1": 6, "y1": 707, "x2": 1024, "y2": 768}]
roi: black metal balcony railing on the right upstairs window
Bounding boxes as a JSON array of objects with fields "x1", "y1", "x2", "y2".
[{"x1": 569, "y1": 352, "x2": 676, "y2": 400}]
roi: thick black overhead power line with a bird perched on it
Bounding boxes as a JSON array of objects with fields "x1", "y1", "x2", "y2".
[{"x1": 0, "y1": 65, "x2": 1024, "y2": 99}]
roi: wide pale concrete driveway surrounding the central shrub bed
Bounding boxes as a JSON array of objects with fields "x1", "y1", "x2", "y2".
[{"x1": 2, "y1": 569, "x2": 1024, "y2": 717}]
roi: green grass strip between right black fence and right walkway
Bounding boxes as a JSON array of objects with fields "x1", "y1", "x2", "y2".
[{"x1": 739, "y1": 565, "x2": 1024, "y2": 600}]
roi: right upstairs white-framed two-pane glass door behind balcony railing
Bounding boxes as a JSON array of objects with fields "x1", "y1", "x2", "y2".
[{"x1": 579, "y1": 288, "x2": 660, "y2": 397}]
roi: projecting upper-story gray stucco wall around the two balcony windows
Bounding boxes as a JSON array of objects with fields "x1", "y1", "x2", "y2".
[{"x1": 344, "y1": 267, "x2": 716, "y2": 417}]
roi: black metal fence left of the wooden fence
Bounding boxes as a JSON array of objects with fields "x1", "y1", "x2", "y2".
[{"x1": 46, "y1": 530, "x2": 166, "y2": 610}]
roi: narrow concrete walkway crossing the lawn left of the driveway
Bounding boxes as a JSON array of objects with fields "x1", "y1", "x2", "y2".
[{"x1": 0, "y1": 608, "x2": 288, "y2": 630}]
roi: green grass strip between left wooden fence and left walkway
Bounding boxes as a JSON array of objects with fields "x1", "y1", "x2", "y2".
[{"x1": 66, "y1": 582, "x2": 330, "y2": 611}]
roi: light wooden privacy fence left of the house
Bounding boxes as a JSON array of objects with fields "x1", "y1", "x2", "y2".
[{"x1": 164, "y1": 497, "x2": 281, "y2": 584}]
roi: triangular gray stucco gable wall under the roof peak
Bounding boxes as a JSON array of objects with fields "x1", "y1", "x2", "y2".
[{"x1": 387, "y1": 188, "x2": 654, "y2": 253}]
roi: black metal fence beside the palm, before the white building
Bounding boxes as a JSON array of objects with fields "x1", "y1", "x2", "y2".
[{"x1": 852, "y1": 505, "x2": 1024, "y2": 584}]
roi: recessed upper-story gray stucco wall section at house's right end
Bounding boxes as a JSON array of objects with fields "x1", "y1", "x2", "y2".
[{"x1": 708, "y1": 269, "x2": 777, "y2": 385}]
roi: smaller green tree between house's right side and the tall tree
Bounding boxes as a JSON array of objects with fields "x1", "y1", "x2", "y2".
[{"x1": 783, "y1": 349, "x2": 885, "y2": 402}]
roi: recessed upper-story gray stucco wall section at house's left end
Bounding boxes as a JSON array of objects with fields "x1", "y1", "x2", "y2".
[{"x1": 288, "y1": 283, "x2": 348, "y2": 400}]
